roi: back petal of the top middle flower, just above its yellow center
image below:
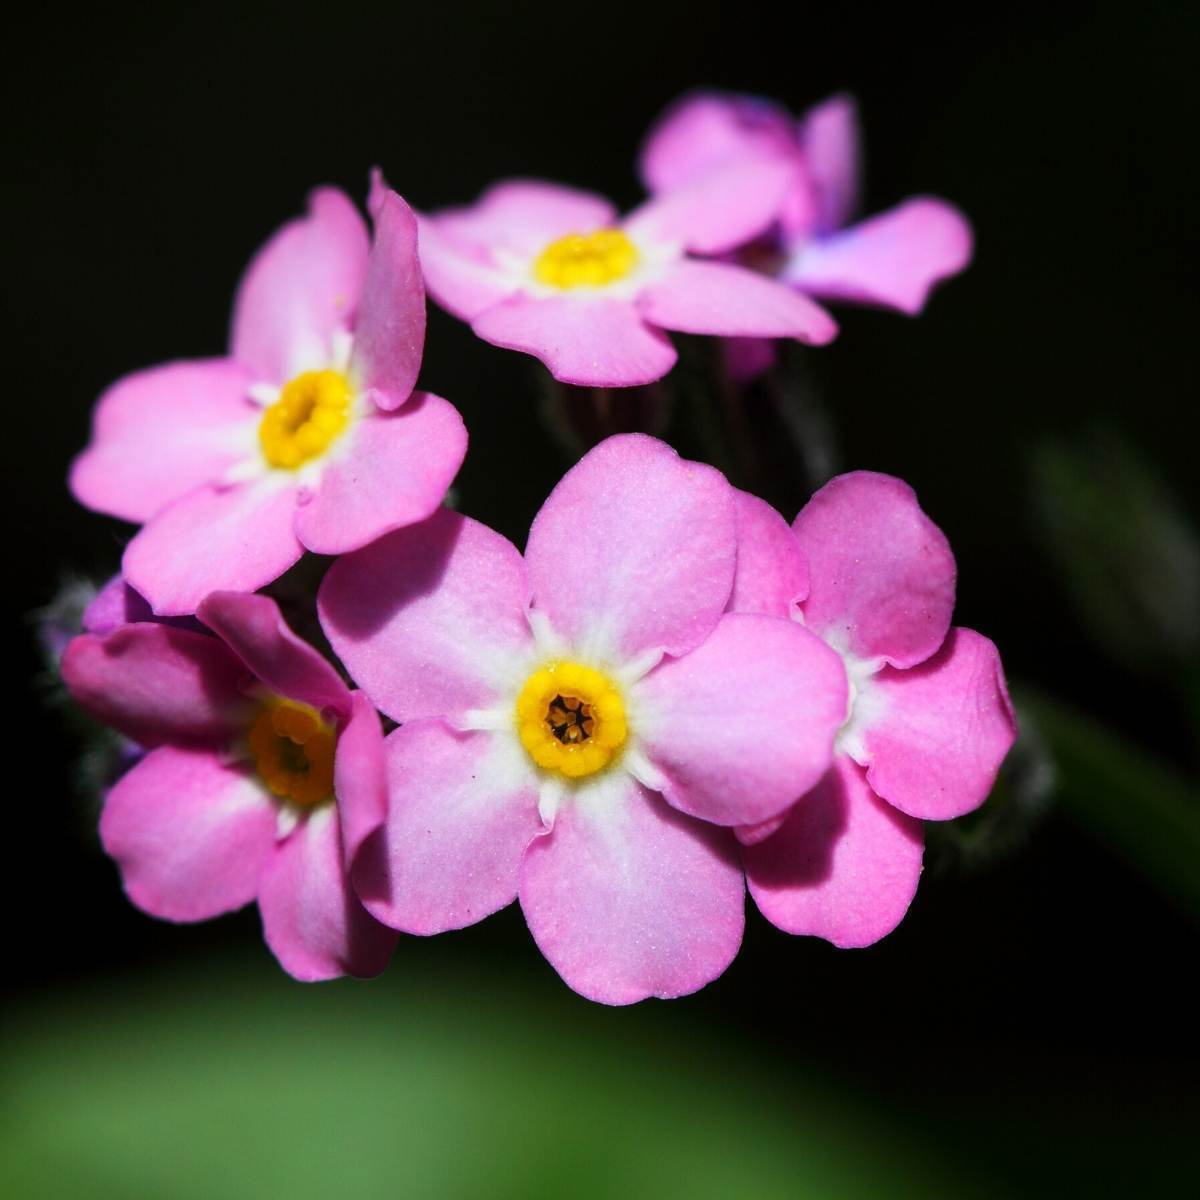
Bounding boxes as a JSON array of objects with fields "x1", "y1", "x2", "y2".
[{"x1": 431, "y1": 179, "x2": 617, "y2": 257}]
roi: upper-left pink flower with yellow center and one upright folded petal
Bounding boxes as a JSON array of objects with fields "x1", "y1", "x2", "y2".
[{"x1": 71, "y1": 188, "x2": 467, "y2": 614}]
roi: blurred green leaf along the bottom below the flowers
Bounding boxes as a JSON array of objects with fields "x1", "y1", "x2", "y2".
[{"x1": 0, "y1": 960, "x2": 977, "y2": 1200}]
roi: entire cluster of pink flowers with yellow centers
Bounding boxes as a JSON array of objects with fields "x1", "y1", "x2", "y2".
[{"x1": 61, "y1": 95, "x2": 1014, "y2": 1004}]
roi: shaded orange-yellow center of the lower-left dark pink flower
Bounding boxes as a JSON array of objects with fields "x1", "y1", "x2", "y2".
[{"x1": 250, "y1": 696, "x2": 337, "y2": 809}]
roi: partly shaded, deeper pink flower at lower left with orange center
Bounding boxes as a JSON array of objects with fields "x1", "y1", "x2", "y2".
[{"x1": 62, "y1": 592, "x2": 396, "y2": 980}]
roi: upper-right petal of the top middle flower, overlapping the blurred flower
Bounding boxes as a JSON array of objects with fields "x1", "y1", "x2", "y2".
[{"x1": 622, "y1": 156, "x2": 799, "y2": 254}]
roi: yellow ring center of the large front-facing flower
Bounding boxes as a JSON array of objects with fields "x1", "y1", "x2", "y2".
[{"x1": 516, "y1": 662, "x2": 629, "y2": 779}]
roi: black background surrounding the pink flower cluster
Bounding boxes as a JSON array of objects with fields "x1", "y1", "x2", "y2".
[{"x1": 0, "y1": 2, "x2": 1200, "y2": 1194}]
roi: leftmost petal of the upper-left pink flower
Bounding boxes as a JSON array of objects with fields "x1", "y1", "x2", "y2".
[{"x1": 70, "y1": 359, "x2": 254, "y2": 523}]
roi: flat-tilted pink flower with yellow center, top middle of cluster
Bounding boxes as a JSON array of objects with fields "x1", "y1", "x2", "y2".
[{"x1": 410, "y1": 171, "x2": 836, "y2": 388}]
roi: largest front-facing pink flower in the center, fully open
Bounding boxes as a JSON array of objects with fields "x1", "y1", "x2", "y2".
[{"x1": 318, "y1": 434, "x2": 846, "y2": 1004}]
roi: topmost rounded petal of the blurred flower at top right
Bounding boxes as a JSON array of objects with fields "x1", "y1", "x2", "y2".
[{"x1": 641, "y1": 92, "x2": 796, "y2": 192}]
